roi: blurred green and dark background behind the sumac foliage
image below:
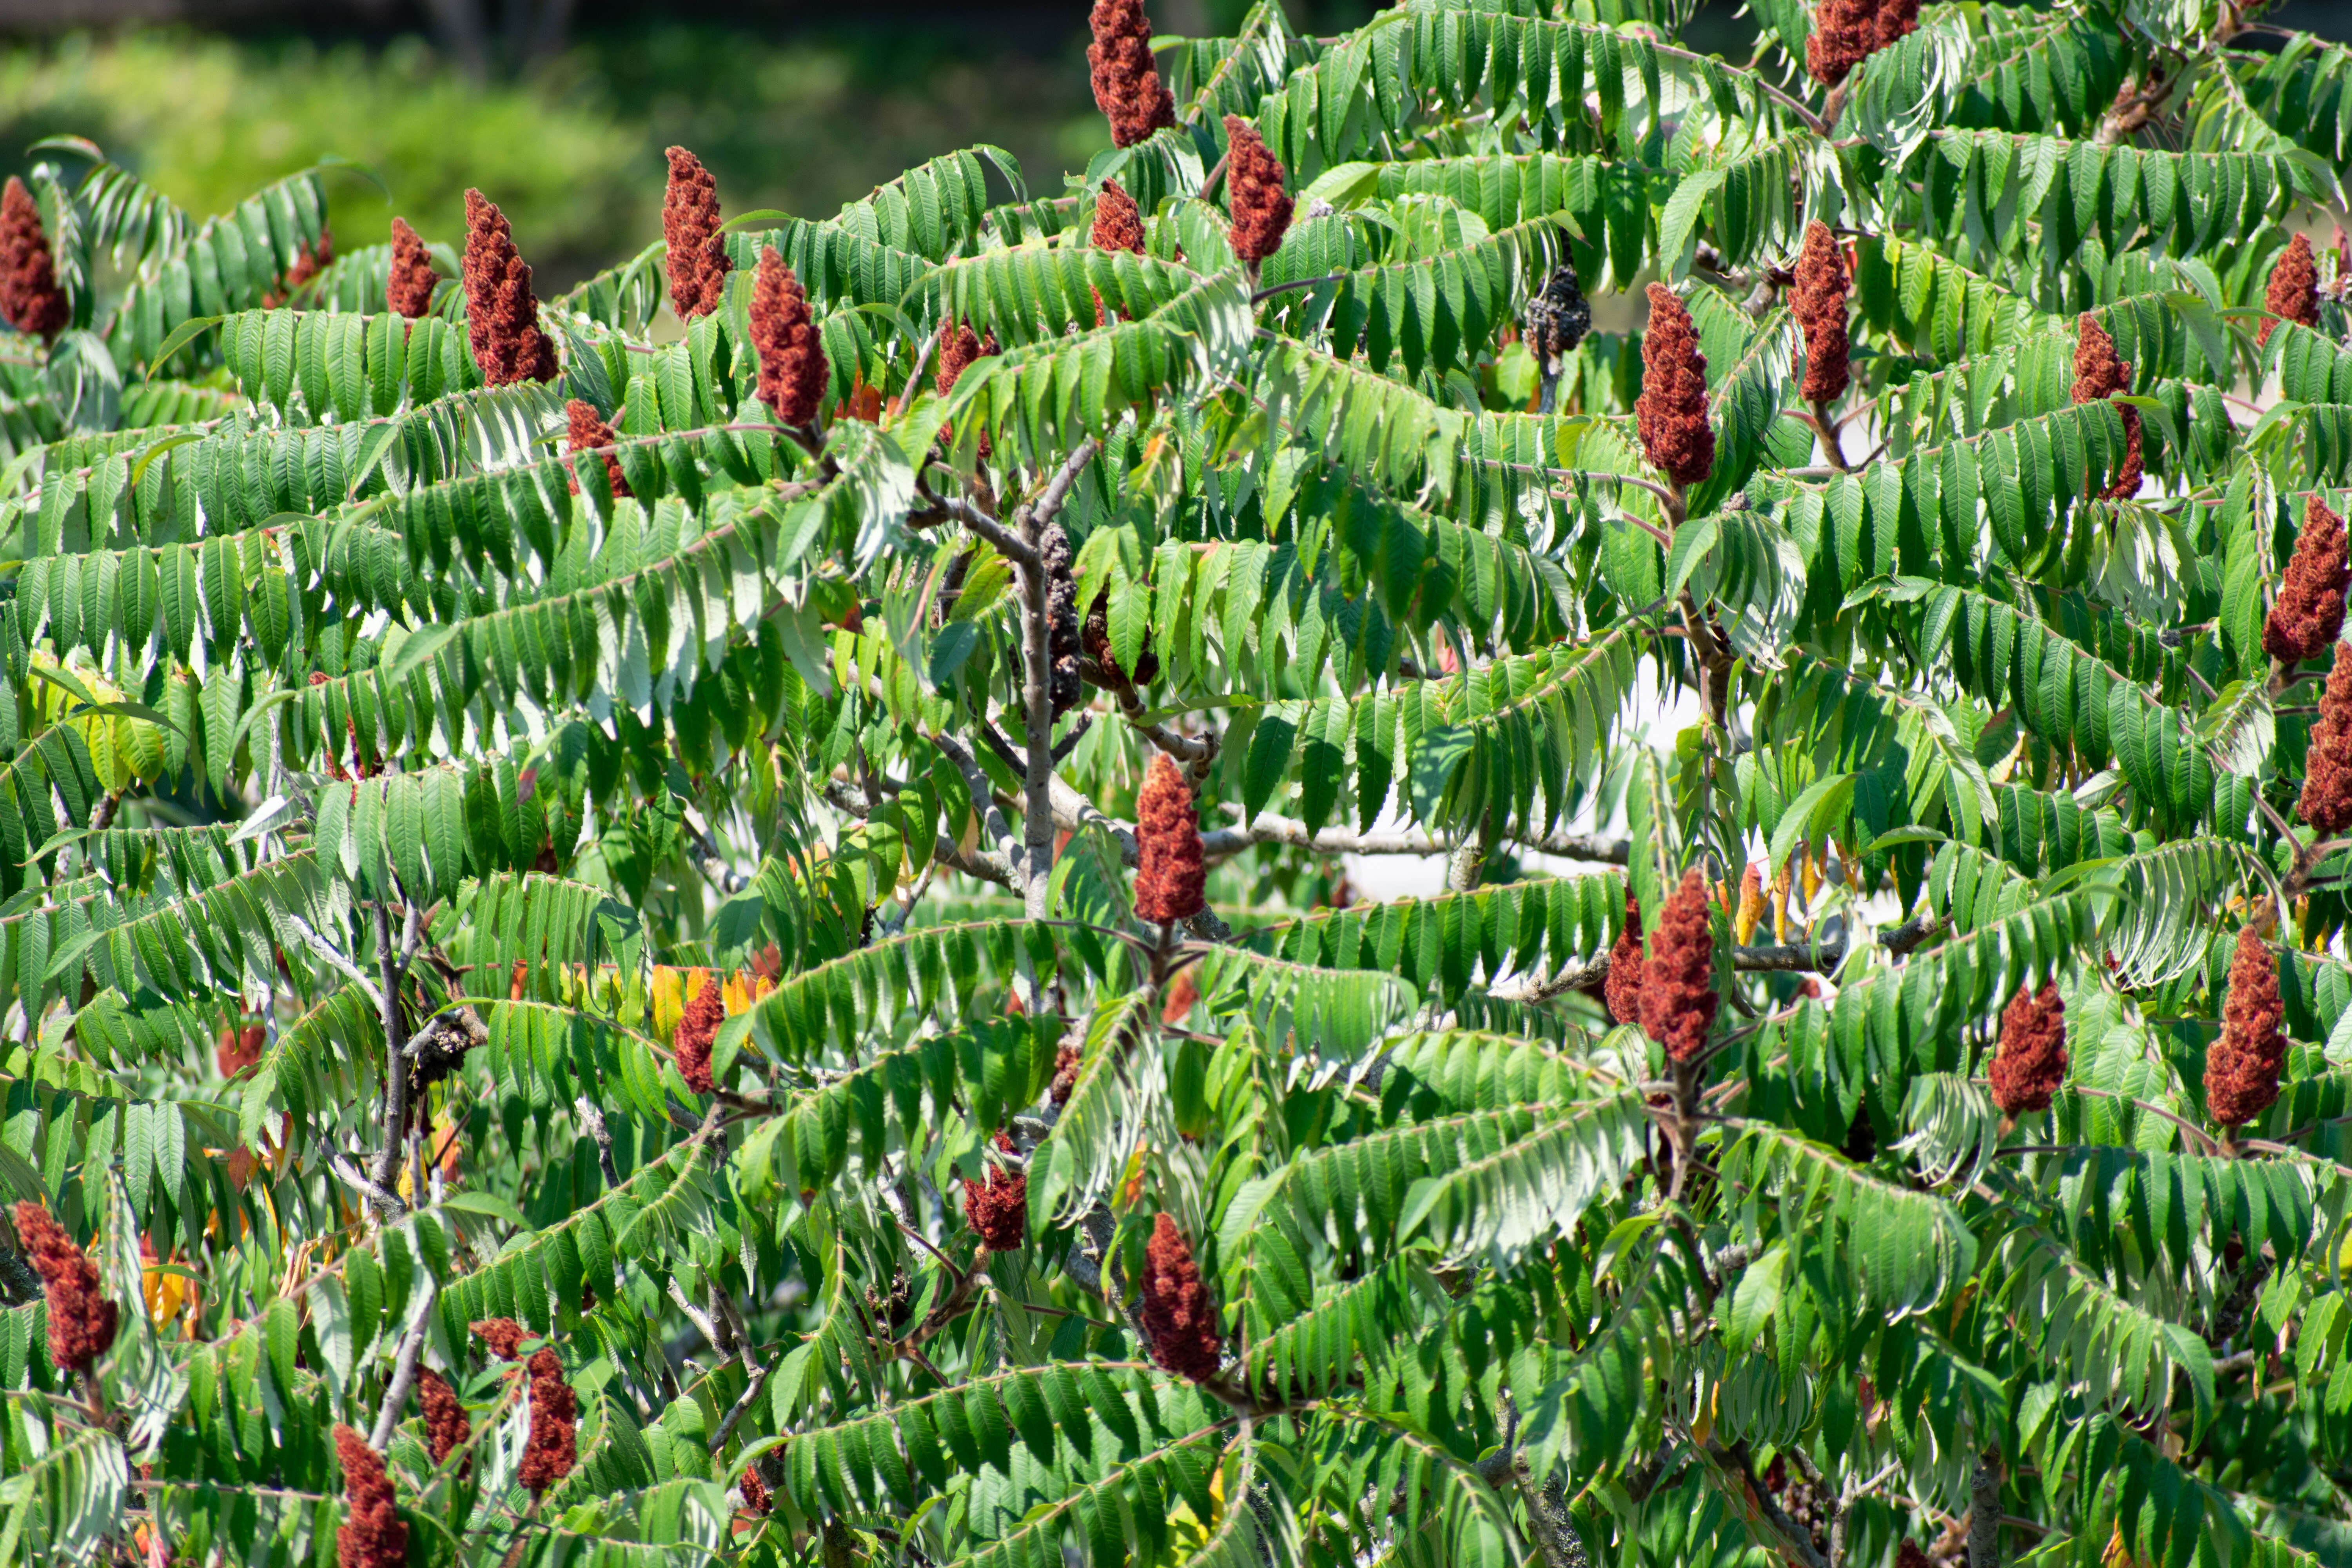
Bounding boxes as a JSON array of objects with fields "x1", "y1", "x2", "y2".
[{"x1": 0, "y1": 0, "x2": 2352, "y2": 289}]
